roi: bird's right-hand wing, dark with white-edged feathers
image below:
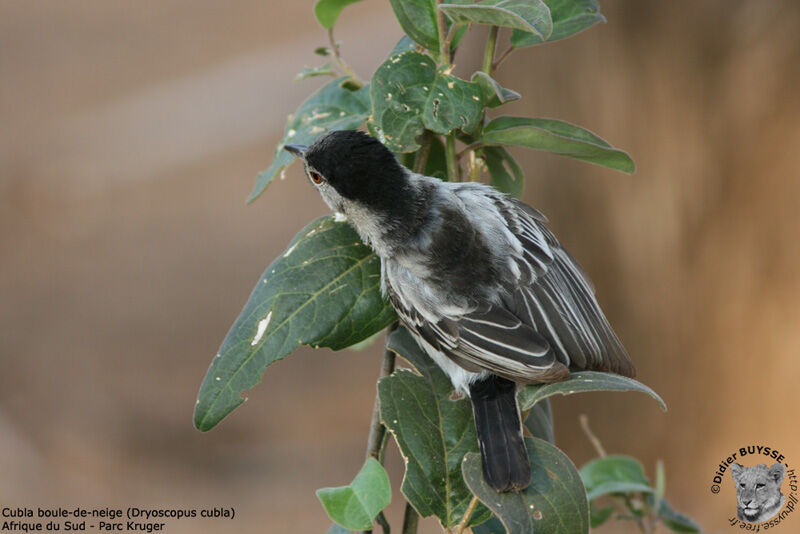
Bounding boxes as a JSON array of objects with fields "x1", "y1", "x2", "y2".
[{"x1": 497, "y1": 197, "x2": 635, "y2": 376}]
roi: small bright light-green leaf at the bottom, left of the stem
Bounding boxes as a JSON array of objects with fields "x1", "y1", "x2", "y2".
[{"x1": 317, "y1": 457, "x2": 392, "y2": 530}]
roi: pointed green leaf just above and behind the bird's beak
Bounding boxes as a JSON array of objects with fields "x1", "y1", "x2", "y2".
[{"x1": 247, "y1": 77, "x2": 370, "y2": 202}]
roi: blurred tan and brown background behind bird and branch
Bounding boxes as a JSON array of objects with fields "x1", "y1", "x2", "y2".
[{"x1": 0, "y1": 0, "x2": 800, "y2": 533}]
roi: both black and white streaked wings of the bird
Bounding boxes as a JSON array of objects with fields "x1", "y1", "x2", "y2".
[{"x1": 386, "y1": 184, "x2": 635, "y2": 383}]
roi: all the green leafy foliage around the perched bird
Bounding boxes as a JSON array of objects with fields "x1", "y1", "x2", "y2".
[{"x1": 195, "y1": 0, "x2": 699, "y2": 534}]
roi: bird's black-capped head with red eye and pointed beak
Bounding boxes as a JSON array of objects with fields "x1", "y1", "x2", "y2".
[{"x1": 285, "y1": 130, "x2": 408, "y2": 218}]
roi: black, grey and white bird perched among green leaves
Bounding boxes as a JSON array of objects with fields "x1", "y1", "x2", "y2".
[{"x1": 284, "y1": 130, "x2": 635, "y2": 492}]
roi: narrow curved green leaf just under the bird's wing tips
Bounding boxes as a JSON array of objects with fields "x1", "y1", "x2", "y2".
[{"x1": 517, "y1": 371, "x2": 667, "y2": 411}]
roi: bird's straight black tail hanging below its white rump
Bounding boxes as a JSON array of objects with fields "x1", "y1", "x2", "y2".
[{"x1": 469, "y1": 375, "x2": 531, "y2": 492}]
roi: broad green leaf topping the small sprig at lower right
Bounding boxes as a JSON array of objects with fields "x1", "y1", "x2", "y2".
[{"x1": 581, "y1": 455, "x2": 654, "y2": 501}]
